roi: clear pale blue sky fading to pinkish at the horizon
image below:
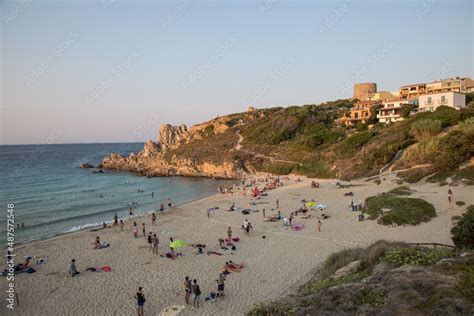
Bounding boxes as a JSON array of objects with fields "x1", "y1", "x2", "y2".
[{"x1": 0, "y1": 0, "x2": 474, "y2": 144}]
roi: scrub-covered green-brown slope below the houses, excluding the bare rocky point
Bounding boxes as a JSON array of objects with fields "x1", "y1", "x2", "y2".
[{"x1": 160, "y1": 94, "x2": 474, "y2": 179}]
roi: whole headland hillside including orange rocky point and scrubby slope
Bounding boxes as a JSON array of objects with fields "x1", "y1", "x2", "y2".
[{"x1": 102, "y1": 96, "x2": 474, "y2": 179}]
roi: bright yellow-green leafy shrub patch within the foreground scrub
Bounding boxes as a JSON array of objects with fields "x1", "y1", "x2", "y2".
[{"x1": 382, "y1": 247, "x2": 453, "y2": 266}]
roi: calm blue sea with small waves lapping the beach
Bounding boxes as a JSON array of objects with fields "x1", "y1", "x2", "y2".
[{"x1": 0, "y1": 143, "x2": 233, "y2": 244}]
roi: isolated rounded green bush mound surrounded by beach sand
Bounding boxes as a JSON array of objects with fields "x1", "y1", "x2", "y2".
[{"x1": 363, "y1": 186, "x2": 436, "y2": 225}]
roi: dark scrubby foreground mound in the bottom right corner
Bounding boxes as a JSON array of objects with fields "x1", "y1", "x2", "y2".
[{"x1": 248, "y1": 241, "x2": 474, "y2": 316}]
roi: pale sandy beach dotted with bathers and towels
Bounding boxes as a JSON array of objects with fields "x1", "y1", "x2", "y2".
[{"x1": 0, "y1": 175, "x2": 474, "y2": 315}]
